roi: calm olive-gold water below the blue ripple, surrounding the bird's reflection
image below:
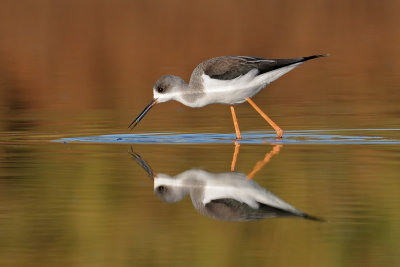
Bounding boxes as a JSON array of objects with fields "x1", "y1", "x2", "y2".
[{"x1": 0, "y1": 137, "x2": 400, "y2": 266}]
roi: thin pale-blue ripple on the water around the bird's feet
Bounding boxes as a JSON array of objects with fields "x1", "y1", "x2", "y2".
[{"x1": 54, "y1": 129, "x2": 400, "y2": 144}]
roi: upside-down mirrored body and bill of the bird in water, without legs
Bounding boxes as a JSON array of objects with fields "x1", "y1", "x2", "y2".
[{"x1": 131, "y1": 152, "x2": 321, "y2": 221}]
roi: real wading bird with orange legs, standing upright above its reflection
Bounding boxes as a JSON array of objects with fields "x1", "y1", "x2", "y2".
[{"x1": 129, "y1": 55, "x2": 325, "y2": 140}]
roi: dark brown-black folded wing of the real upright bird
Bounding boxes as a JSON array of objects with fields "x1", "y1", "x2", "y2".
[{"x1": 204, "y1": 55, "x2": 325, "y2": 80}]
